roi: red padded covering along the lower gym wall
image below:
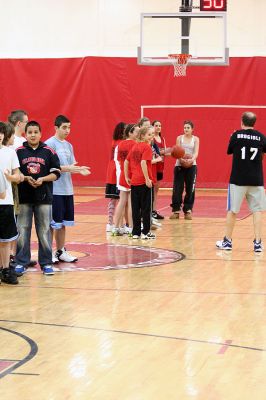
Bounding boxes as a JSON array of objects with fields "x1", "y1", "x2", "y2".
[{"x1": 0, "y1": 57, "x2": 266, "y2": 187}]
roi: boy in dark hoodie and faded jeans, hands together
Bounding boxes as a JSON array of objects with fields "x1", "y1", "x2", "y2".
[{"x1": 16, "y1": 121, "x2": 60, "y2": 275}]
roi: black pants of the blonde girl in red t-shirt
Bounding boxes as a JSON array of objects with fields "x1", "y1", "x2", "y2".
[{"x1": 131, "y1": 185, "x2": 151, "y2": 236}]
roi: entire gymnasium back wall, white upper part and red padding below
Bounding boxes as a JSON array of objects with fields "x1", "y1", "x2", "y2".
[{"x1": 0, "y1": 0, "x2": 266, "y2": 187}]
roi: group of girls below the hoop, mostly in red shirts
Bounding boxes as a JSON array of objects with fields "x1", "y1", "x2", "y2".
[{"x1": 105, "y1": 117, "x2": 199, "y2": 239}]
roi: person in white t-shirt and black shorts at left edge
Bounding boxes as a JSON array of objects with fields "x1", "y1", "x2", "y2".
[{"x1": 0, "y1": 122, "x2": 20, "y2": 285}]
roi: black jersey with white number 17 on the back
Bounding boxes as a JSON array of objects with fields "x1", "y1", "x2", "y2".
[{"x1": 227, "y1": 129, "x2": 266, "y2": 186}]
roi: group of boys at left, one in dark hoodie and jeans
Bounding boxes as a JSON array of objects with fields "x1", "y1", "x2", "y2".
[{"x1": 0, "y1": 110, "x2": 90, "y2": 284}]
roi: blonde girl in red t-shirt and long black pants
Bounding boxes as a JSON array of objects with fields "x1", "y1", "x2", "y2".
[{"x1": 124, "y1": 127, "x2": 155, "y2": 239}]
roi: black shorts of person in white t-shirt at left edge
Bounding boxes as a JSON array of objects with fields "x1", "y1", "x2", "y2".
[{"x1": 0, "y1": 204, "x2": 18, "y2": 242}]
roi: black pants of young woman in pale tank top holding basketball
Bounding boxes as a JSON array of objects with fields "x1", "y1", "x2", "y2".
[{"x1": 171, "y1": 165, "x2": 197, "y2": 212}]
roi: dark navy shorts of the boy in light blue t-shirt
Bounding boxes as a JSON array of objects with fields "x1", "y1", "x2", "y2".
[{"x1": 51, "y1": 194, "x2": 75, "y2": 229}]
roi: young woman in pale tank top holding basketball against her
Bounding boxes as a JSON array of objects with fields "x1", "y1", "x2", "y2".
[{"x1": 170, "y1": 121, "x2": 199, "y2": 220}]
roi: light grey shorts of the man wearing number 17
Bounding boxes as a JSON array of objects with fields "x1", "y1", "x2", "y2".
[{"x1": 227, "y1": 183, "x2": 266, "y2": 214}]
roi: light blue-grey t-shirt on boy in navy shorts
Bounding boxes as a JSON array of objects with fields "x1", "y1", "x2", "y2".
[{"x1": 45, "y1": 136, "x2": 76, "y2": 196}]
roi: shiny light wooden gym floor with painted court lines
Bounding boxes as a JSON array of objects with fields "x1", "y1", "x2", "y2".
[{"x1": 0, "y1": 188, "x2": 266, "y2": 400}]
